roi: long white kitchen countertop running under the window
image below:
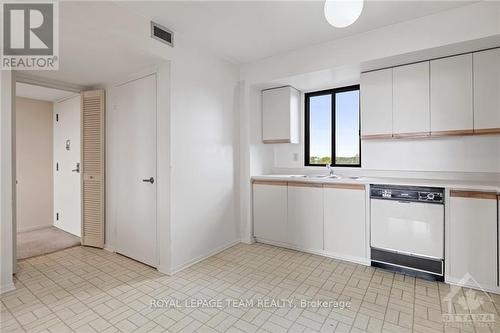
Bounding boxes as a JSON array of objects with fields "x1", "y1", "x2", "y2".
[{"x1": 252, "y1": 174, "x2": 500, "y2": 193}]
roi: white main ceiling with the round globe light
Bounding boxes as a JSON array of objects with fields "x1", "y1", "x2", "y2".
[{"x1": 119, "y1": 0, "x2": 471, "y2": 64}]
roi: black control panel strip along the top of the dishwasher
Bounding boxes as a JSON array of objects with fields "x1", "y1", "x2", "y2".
[{"x1": 370, "y1": 185, "x2": 444, "y2": 204}]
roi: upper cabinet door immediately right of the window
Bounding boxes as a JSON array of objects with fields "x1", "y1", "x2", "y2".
[{"x1": 360, "y1": 68, "x2": 392, "y2": 138}]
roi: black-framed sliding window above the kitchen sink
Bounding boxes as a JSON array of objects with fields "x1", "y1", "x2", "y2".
[{"x1": 305, "y1": 85, "x2": 361, "y2": 167}]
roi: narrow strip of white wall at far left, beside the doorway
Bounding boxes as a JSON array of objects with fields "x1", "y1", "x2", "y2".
[{"x1": 0, "y1": 71, "x2": 15, "y2": 293}]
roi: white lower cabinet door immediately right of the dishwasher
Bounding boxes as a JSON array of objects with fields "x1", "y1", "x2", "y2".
[{"x1": 446, "y1": 191, "x2": 498, "y2": 288}]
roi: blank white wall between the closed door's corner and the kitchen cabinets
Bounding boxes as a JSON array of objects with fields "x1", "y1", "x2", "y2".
[{"x1": 171, "y1": 48, "x2": 239, "y2": 271}]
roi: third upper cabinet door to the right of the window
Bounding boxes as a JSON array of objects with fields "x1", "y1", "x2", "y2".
[{"x1": 431, "y1": 54, "x2": 474, "y2": 135}]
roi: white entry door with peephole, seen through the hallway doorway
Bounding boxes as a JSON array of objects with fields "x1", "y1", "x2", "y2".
[{"x1": 53, "y1": 95, "x2": 81, "y2": 237}]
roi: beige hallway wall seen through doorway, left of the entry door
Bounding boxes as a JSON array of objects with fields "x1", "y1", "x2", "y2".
[{"x1": 16, "y1": 97, "x2": 54, "y2": 232}]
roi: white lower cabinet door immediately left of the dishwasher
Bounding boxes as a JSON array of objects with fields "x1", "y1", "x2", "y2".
[{"x1": 323, "y1": 185, "x2": 366, "y2": 260}]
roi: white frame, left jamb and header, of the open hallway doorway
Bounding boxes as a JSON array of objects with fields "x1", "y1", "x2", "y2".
[{"x1": 11, "y1": 71, "x2": 84, "y2": 274}]
